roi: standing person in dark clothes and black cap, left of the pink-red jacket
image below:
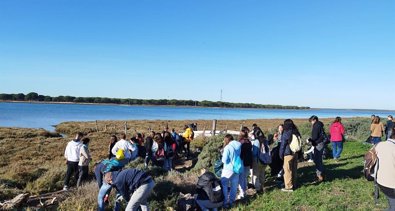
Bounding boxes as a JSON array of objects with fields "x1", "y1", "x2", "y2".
[{"x1": 308, "y1": 115, "x2": 325, "y2": 182}]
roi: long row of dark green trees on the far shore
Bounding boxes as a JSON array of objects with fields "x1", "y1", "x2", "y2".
[{"x1": 0, "y1": 92, "x2": 310, "y2": 109}]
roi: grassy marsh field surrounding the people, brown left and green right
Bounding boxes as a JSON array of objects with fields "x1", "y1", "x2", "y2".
[{"x1": 0, "y1": 118, "x2": 386, "y2": 210}]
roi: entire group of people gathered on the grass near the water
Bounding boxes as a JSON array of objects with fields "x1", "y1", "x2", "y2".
[{"x1": 60, "y1": 116, "x2": 395, "y2": 210}]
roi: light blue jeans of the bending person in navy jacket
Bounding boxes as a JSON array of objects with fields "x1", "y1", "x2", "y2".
[{"x1": 125, "y1": 180, "x2": 155, "y2": 211}]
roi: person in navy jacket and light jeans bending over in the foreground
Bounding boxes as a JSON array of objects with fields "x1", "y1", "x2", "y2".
[{"x1": 104, "y1": 168, "x2": 155, "y2": 211}]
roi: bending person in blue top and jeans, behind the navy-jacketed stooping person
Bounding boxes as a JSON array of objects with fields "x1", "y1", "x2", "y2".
[{"x1": 94, "y1": 149, "x2": 128, "y2": 211}]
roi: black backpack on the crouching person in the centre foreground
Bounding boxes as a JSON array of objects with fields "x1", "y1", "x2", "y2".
[{"x1": 197, "y1": 172, "x2": 225, "y2": 203}]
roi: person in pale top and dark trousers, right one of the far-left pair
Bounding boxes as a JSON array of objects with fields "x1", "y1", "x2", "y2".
[{"x1": 77, "y1": 138, "x2": 92, "y2": 187}]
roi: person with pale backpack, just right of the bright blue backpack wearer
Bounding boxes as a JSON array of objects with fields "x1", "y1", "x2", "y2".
[{"x1": 251, "y1": 134, "x2": 270, "y2": 193}]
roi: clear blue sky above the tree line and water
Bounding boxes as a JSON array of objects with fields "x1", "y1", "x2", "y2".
[{"x1": 0, "y1": 0, "x2": 395, "y2": 109}]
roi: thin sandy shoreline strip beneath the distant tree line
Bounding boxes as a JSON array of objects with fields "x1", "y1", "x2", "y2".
[{"x1": 0, "y1": 100, "x2": 312, "y2": 110}]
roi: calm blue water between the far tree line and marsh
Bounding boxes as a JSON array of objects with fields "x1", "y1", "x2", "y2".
[{"x1": 0, "y1": 103, "x2": 395, "y2": 130}]
